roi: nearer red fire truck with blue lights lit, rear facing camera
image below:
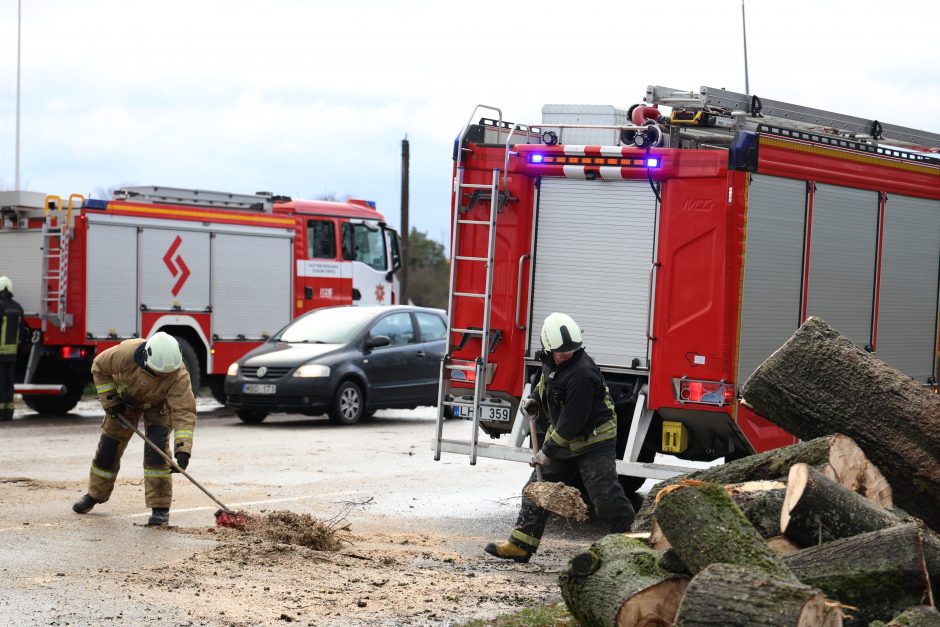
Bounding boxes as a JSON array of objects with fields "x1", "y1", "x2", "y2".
[{"x1": 433, "y1": 86, "x2": 940, "y2": 489}]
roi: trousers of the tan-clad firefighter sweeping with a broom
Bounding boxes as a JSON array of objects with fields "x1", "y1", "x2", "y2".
[{"x1": 88, "y1": 409, "x2": 173, "y2": 508}]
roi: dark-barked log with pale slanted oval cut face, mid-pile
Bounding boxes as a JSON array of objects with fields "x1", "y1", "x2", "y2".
[{"x1": 779, "y1": 464, "x2": 904, "y2": 546}]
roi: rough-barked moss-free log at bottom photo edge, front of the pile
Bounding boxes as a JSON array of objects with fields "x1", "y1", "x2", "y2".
[{"x1": 674, "y1": 564, "x2": 842, "y2": 627}]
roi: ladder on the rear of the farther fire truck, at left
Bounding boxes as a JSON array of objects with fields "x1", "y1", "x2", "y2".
[{"x1": 39, "y1": 194, "x2": 85, "y2": 331}]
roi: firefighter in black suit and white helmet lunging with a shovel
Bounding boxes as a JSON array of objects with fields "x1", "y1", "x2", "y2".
[{"x1": 484, "y1": 313, "x2": 635, "y2": 562}]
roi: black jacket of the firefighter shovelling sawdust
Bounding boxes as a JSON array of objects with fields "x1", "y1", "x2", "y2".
[{"x1": 536, "y1": 349, "x2": 617, "y2": 457}]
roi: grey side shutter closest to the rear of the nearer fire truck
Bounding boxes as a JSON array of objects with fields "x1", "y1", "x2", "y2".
[{"x1": 738, "y1": 174, "x2": 806, "y2": 382}]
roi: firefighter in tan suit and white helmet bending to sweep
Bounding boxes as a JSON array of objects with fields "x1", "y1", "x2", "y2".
[{"x1": 72, "y1": 331, "x2": 196, "y2": 526}]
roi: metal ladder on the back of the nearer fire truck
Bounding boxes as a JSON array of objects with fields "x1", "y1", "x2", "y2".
[{"x1": 434, "y1": 105, "x2": 509, "y2": 464}]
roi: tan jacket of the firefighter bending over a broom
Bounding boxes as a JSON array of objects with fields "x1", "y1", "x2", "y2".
[{"x1": 91, "y1": 339, "x2": 196, "y2": 453}]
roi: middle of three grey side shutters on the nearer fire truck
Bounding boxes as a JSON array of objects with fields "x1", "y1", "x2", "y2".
[{"x1": 806, "y1": 184, "x2": 879, "y2": 347}]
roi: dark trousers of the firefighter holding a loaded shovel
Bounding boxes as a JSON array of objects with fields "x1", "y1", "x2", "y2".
[{"x1": 509, "y1": 442, "x2": 636, "y2": 553}]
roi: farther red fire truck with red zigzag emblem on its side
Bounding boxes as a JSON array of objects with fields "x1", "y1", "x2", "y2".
[{"x1": 0, "y1": 187, "x2": 401, "y2": 413}]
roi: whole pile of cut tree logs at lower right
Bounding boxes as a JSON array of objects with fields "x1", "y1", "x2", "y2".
[{"x1": 560, "y1": 318, "x2": 940, "y2": 627}]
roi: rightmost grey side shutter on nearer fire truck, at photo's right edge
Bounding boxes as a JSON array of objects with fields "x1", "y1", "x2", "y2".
[{"x1": 875, "y1": 194, "x2": 940, "y2": 383}]
